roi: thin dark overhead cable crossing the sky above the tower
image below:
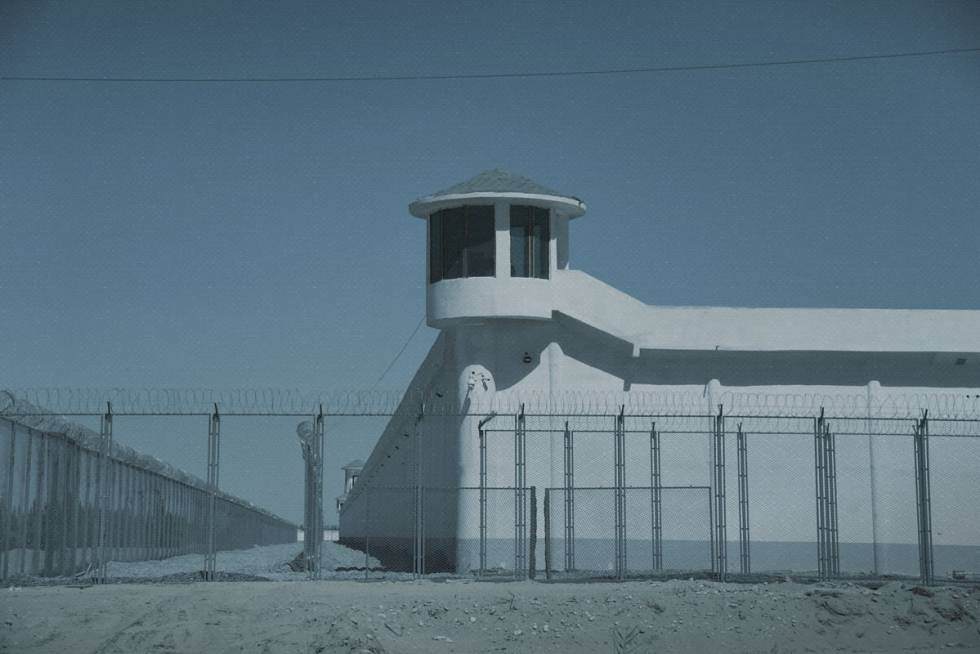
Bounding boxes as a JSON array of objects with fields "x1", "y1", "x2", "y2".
[{"x1": 0, "y1": 47, "x2": 980, "y2": 84}]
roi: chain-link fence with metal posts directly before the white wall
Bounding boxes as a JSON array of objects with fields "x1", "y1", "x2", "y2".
[{"x1": 444, "y1": 406, "x2": 980, "y2": 581}]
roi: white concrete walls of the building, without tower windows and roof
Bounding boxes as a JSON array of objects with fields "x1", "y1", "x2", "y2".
[{"x1": 340, "y1": 194, "x2": 980, "y2": 571}]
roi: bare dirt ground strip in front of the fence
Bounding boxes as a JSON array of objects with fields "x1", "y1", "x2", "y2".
[{"x1": 0, "y1": 580, "x2": 980, "y2": 654}]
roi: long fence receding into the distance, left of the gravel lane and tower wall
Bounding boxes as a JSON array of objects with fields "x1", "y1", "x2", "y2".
[{"x1": 0, "y1": 418, "x2": 296, "y2": 579}]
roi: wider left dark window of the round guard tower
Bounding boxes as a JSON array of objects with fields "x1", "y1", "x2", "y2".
[{"x1": 429, "y1": 206, "x2": 495, "y2": 284}]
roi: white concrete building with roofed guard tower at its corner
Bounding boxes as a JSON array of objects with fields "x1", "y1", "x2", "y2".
[{"x1": 338, "y1": 170, "x2": 980, "y2": 572}]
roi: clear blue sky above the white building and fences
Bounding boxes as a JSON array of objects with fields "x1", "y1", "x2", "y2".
[{"x1": 0, "y1": 0, "x2": 980, "y2": 518}]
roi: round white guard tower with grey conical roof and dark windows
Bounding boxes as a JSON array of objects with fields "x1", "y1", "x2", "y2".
[{"x1": 409, "y1": 169, "x2": 585, "y2": 329}]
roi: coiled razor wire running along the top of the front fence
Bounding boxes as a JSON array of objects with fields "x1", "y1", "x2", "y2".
[{"x1": 7, "y1": 386, "x2": 980, "y2": 420}]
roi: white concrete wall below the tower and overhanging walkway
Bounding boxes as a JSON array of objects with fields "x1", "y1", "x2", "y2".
[{"x1": 341, "y1": 310, "x2": 980, "y2": 570}]
